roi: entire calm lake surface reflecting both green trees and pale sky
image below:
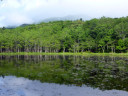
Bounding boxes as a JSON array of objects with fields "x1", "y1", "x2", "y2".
[{"x1": 0, "y1": 55, "x2": 128, "y2": 96}]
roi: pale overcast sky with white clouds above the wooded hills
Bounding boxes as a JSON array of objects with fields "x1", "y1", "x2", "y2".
[{"x1": 0, "y1": 0, "x2": 128, "y2": 27}]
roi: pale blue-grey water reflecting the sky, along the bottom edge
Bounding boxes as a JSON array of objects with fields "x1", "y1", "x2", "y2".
[{"x1": 0, "y1": 76, "x2": 128, "y2": 96}]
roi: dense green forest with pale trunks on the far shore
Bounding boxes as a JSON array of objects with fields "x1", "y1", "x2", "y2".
[{"x1": 0, "y1": 17, "x2": 128, "y2": 53}]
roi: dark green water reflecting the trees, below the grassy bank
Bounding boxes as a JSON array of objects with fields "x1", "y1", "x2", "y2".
[{"x1": 0, "y1": 55, "x2": 128, "y2": 96}]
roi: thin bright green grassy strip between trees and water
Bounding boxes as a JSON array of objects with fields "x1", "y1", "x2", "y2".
[{"x1": 0, "y1": 52, "x2": 128, "y2": 56}]
